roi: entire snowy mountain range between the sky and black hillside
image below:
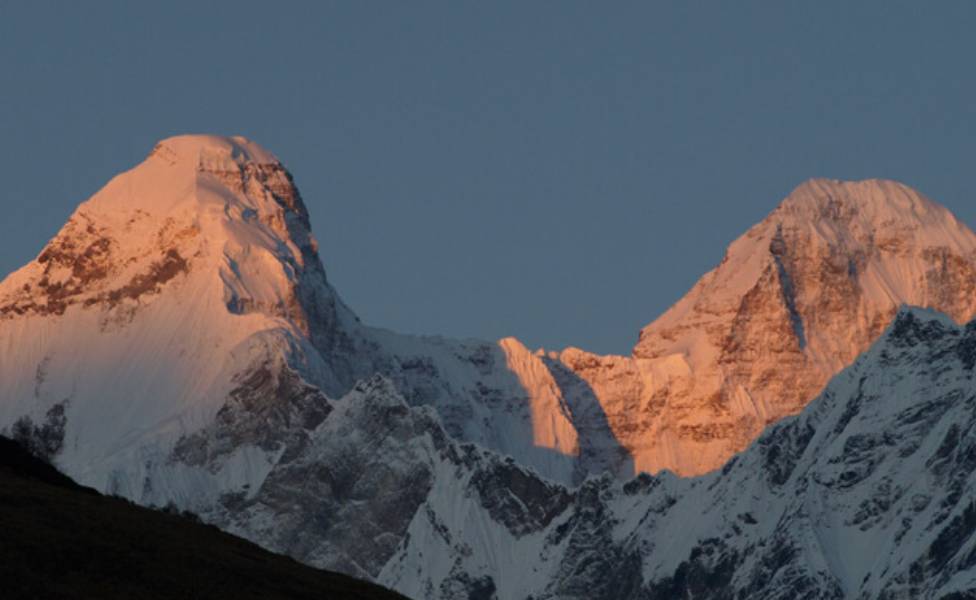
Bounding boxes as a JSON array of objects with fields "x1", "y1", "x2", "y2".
[{"x1": 0, "y1": 136, "x2": 976, "y2": 600}]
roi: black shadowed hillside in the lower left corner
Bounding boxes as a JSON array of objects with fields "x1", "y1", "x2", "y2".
[{"x1": 0, "y1": 437, "x2": 403, "y2": 600}]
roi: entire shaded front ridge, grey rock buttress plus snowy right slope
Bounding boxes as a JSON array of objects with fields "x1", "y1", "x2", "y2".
[{"x1": 57, "y1": 309, "x2": 964, "y2": 600}]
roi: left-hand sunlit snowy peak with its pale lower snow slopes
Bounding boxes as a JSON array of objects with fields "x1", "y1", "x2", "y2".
[{"x1": 0, "y1": 135, "x2": 357, "y2": 488}]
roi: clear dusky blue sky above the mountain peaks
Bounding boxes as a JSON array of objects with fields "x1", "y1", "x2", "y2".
[{"x1": 0, "y1": 0, "x2": 976, "y2": 353}]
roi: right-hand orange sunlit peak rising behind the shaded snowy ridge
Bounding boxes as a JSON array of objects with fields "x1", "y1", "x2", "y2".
[{"x1": 559, "y1": 179, "x2": 976, "y2": 475}]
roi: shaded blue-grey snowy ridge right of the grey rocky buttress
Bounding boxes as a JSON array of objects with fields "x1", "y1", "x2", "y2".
[{"x1": 380, "y1": 309, "x2": 976, "y2": 600}]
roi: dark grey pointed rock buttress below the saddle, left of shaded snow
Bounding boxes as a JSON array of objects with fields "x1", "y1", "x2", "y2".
[{"x1": 211, "y1": 374, "x2": 449, "y2": 578}]
